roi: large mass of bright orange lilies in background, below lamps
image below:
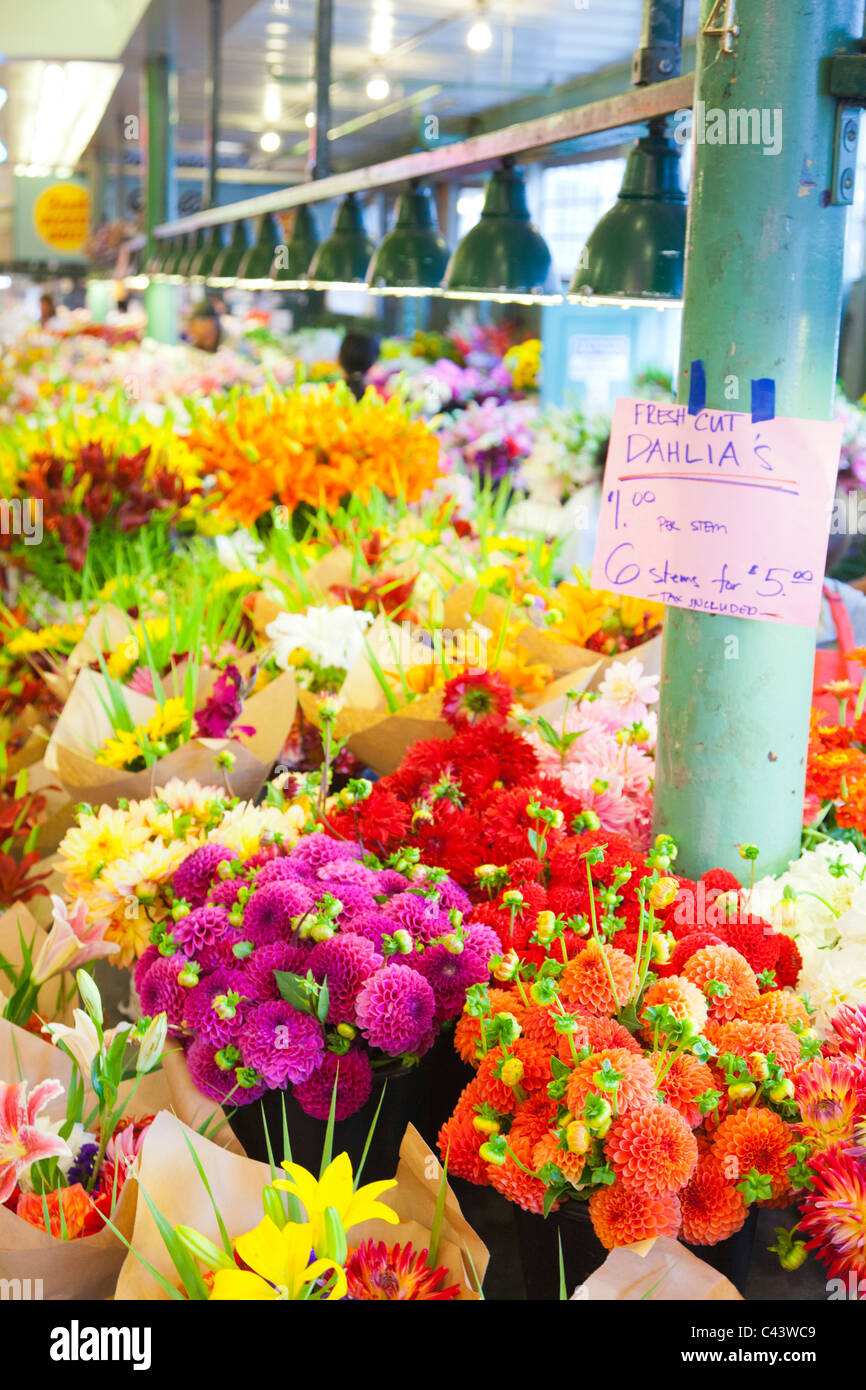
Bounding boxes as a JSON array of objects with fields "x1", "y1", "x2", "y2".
[{"x1": 189, "y1": 386, "x2": 439, "y2": 525}]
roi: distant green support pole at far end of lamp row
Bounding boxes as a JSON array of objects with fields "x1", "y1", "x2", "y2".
[{"x1": 145, "y1": 54, "x2": 178, "y2": 343}]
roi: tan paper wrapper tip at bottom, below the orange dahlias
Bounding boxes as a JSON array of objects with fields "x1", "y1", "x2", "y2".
[{"x1": 571, "y1": 1236, "x2": 742, "y2": 1302}]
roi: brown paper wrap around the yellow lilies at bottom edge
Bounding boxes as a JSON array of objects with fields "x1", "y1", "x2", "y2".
[{"x1": 114, "y1": 1113, "x2": 488, "y2": 1301}]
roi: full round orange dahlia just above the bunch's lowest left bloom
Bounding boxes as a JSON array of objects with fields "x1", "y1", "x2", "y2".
[{"x1": 605, "y1": 1105, "x2": 698, "y2": 1197}]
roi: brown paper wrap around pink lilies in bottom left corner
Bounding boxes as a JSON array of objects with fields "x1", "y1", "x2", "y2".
[{"x1": 0, "y1": 1019, "x2": 168, "y2": 1301}]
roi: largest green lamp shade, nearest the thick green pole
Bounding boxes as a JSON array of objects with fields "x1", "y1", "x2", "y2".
[{"x1": 569, "y1": 128, "x2": 685, "y2": 306}]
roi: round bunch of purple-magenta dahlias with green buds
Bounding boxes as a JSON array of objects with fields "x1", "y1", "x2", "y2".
[{"x1": 135, "y1": 828, "x2": 495, "y2": 1119}]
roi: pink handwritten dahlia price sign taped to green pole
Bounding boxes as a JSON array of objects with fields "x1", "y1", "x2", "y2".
[{"x1": 592, "y1": 399, "x2": 842, "y2": 627}]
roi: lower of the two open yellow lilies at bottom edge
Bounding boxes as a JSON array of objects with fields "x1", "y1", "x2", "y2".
[{"x1": 210, "y1": 1223, "x2": 348, "y2": 1302}]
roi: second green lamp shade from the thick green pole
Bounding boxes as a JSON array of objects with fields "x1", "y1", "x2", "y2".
[{"x1": 445, "y1": 165, "x2": 560, "y2": 300}]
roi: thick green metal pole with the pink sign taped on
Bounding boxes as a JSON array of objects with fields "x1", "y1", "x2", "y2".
[{"x1": 653, "y1": 0, "x2": 863, "y2": 876}]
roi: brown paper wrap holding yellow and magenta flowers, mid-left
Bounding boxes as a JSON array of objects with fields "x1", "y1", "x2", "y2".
[{"x1": 44, "y1": 670, "x2": 296, "y2": 806}]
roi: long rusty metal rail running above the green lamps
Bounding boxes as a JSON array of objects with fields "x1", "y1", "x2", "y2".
[{"x1": 156, "y1": 74, "x2": 694, "y2": 238}]
